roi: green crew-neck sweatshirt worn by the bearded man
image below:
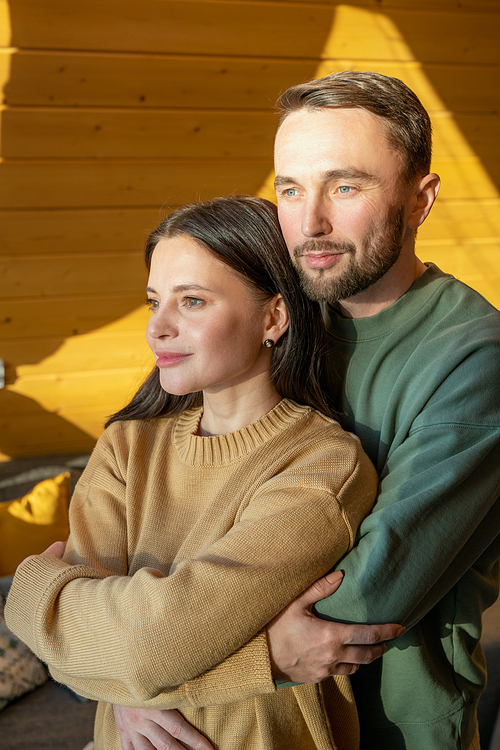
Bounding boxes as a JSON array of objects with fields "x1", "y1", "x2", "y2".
[{"x1": 317, "y1": 265, "x2": 500, "y2": 750}]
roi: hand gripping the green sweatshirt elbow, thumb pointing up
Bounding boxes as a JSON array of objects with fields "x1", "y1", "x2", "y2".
[{"x1": 267, "y1": 571, "x2": 405, "y2": 683}]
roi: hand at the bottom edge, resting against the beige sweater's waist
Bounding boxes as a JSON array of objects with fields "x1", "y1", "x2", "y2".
[{"x1": 113, "y1": 706, "x2": 214, "y2": 750}]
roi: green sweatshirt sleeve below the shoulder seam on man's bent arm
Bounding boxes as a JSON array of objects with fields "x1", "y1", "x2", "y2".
[{"x1": 316, "y1": 423, "x2": 500, "y2": 628}]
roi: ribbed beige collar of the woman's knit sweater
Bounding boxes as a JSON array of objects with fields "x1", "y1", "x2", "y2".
[{"x1": 173, "y1": 399, "x2": 310, "y2": 466}]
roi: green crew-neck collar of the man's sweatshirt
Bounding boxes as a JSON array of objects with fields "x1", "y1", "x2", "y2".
[{"x1": 325, "y1": 263, "x2": 453, "y2": 342}]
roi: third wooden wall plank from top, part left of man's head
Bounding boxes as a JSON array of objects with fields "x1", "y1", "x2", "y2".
[{"x1": 2, "y1": 108, "x2": 277, "y2": 159}]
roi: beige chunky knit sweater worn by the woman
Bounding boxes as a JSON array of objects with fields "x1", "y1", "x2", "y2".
[{"x1": 6, "y1": 400, "x2": 377, "y2": 750}]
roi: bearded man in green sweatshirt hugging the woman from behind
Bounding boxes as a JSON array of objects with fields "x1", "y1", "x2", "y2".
[{"x1": 101, "y1": 72, "x2": 500, "y2": 750}]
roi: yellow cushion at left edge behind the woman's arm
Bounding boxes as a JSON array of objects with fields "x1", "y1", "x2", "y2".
[{"x1": 0, "y1": 472, "x2": 70, "y2": 576}]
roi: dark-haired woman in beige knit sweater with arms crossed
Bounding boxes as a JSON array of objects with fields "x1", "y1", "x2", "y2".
[{"x1": 7, "y1": 197, "x2": 377, "y2": 750}]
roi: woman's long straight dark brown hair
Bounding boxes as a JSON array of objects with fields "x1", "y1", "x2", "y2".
[{"x1": 106, "y1": 195, "x2": 335, "y2": 427}]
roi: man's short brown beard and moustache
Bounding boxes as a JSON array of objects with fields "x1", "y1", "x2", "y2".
[{"x1": 292, "y1": 206, "x2": 404, "y2": 304}]
